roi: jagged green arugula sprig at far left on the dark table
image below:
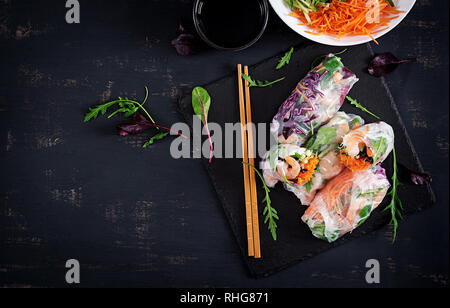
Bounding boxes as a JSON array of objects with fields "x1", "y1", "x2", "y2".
[{"x1": 84, "y1": 87, "x2": 156, "y2": 124}]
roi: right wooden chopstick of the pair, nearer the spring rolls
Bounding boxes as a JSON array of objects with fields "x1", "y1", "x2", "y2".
[{"x1": 244, "y1": 66, "x2": 261, "y2": 259}]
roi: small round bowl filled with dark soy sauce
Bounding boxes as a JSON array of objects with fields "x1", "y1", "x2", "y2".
[{"x1": 194, "y1": 0, "x2": 269, "y2": 51}]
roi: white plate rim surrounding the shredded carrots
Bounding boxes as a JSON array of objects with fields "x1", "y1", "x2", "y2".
[{"x1": 269, "y1": 0, "x2": 416, "y2": 46}]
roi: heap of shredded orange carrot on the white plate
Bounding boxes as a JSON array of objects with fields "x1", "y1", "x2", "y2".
[{"x1": 290, "y1": 0, "x2": 403, "y2": 44}]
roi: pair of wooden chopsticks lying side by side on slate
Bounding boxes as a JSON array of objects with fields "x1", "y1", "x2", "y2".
[{"x1": 238, "y1": 64, "x2": 261, "y2": 259}]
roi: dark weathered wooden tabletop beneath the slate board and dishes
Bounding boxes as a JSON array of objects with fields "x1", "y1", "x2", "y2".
[{"x1": 0, "y1": 0, "x2": 449, "y2": 287}]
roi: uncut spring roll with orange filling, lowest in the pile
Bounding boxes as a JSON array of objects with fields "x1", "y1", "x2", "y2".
[{"x1": 302, "y1": 165, "x2": 390, "y2": 243}]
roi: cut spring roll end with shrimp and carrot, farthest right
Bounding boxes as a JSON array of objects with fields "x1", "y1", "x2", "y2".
[{"x1": 340, "y1": 122, "x2": 395, "y2": 171}]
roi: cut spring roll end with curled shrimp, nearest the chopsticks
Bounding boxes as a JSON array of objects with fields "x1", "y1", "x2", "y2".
[{"x1": 261, "y1": 144, "x2": 319, "y2": 187}]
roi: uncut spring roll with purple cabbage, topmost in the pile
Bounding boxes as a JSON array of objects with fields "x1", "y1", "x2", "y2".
[{"x1": 270, "y1": 54, "x2": 358, "y2": 146}]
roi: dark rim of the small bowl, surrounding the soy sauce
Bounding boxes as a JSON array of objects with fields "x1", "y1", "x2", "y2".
[{"x1": 193, "y1": 0, "x2": 269, "y2": 51}]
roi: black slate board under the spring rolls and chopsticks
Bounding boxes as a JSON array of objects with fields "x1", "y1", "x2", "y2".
[{"x1": 179, "y1": 43, "x2": 435, "y2": 277}]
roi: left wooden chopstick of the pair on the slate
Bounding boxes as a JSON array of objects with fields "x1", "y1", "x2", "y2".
[{"x1": 238, "y1": 64, "x2": 255, "y2": 257}]
